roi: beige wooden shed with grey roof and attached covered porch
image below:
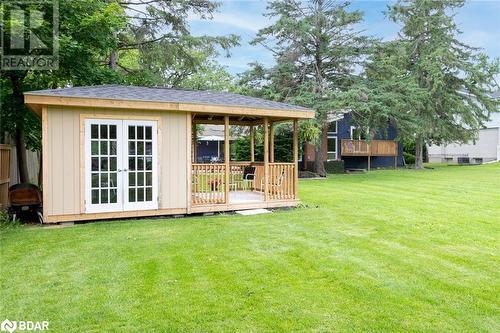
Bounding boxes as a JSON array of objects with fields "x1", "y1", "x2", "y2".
[{"x1": 24, "y1": 85, "x2": 314, "y2": 223}]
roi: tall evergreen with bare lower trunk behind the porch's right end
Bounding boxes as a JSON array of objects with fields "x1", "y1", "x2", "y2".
[{"x1": 243, "y1": 0, "x2": 373, "y2": 176}]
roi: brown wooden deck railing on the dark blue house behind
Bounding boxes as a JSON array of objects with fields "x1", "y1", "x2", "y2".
[{"x1": 341, "y1": 139, "x2": 398, "y2": 156}]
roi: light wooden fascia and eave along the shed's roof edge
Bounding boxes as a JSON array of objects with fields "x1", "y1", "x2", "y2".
[{"x1": 24, "y1": 93, "x2": 314, "y2": 119}]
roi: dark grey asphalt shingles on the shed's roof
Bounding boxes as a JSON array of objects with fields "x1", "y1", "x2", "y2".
[{"x1": 26, "y1": 85, "x2": 312, "y2": 112}]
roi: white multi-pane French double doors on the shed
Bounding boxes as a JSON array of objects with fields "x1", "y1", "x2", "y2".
[{"x1": 85, "y1": 119, "x2": 158, "y2": 213}]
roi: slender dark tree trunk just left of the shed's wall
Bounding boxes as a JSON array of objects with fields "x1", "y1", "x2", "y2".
[{"x1": 9, "y1": 72, "x2": 29, "y2": 183}]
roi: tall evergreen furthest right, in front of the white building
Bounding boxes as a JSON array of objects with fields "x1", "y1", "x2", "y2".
[{"x1": 389, "y1": 0, "x2": 500, "y2": 169}]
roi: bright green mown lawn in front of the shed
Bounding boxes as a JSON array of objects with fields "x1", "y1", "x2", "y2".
[{"x1": 0, "y1": 163, "x2": 500, "y2": 332}]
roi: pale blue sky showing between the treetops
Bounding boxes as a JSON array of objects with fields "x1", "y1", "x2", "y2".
[{"x1": 189, "y1": 0, "x2": 500, "y2": 74}]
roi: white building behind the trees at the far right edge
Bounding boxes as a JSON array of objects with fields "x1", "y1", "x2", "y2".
[{"x1": 427, "y1": 92, "x2": 500, "y2": 163}]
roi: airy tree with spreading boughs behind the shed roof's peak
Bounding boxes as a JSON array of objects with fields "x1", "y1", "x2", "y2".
[{"x1": 107, "y1": 0, "x2": 239, "y2": 87}]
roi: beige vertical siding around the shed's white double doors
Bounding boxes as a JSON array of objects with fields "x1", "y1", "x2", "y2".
[{"x1": 44, "y1": 107, "x2": 188, "y2": 216}]
